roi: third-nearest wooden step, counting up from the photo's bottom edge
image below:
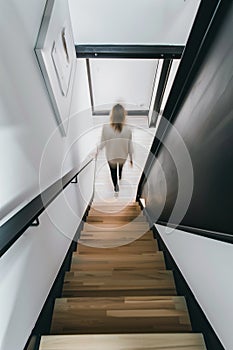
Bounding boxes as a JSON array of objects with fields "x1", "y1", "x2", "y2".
[{"x1": 63, "y1": 269, "x2": 176, "y2": 297}]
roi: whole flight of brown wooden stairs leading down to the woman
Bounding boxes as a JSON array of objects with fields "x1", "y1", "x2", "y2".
[{"x1": 40, "y1": 203, "x2": 206, "y2": 350}]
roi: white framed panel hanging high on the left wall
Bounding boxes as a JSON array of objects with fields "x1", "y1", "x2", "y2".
[{"x1": 35, "y1": 0, "x2": 76, "y2": 136}]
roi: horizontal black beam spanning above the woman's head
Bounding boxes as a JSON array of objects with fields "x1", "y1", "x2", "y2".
[{"x1": 75, "y1": 45, "x2": 184, "y2": 59}]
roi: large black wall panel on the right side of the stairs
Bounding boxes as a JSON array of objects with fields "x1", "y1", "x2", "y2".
[{"x1": 144, "y1": 6, "x2": 233, "y2": 234}]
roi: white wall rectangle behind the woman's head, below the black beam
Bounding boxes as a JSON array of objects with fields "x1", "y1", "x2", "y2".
[{"x1": 90, "y1": 59, "x2": 157, "y2": 110}]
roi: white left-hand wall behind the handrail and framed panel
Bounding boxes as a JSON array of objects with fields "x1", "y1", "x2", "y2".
[{"x1": 0, "y1": 0, "x2": 95, "y2": 350}]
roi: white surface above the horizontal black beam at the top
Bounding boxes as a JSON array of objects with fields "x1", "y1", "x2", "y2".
[{"x1": 68, "y1": 0, "x2": 201, "y2": 45}]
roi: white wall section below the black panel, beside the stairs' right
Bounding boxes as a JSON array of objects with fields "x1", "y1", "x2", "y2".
[{"x1": 155, "y1": 225, "x2": 233, "y2": 350}]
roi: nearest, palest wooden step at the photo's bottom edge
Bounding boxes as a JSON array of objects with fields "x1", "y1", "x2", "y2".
[{"x1": 39, "y1": 333, "x2": 206, "y2": 350}]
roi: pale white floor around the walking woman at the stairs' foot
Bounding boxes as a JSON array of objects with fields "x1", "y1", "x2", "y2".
[{"x1": 93, "y1": 116, "x2": 155, "y2": 205}]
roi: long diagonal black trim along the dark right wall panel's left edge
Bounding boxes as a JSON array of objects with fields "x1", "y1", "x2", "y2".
[{"x1": 137, "y1": 0, "x2": 231, "y2": 198}]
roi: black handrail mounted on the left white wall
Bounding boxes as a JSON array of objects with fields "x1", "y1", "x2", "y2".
[{"x1": 0, "y1": 158, "x2": 95, "y2": 257}]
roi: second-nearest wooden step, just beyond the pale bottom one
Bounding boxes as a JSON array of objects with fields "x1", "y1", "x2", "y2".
[{"x1": 51, "y1": 296, "x2": 191, "y2": 334}]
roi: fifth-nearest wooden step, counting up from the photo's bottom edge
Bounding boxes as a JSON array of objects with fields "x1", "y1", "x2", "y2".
[{"x1": 76, "y1": 238, "x2": 158, "y2": 255}]
